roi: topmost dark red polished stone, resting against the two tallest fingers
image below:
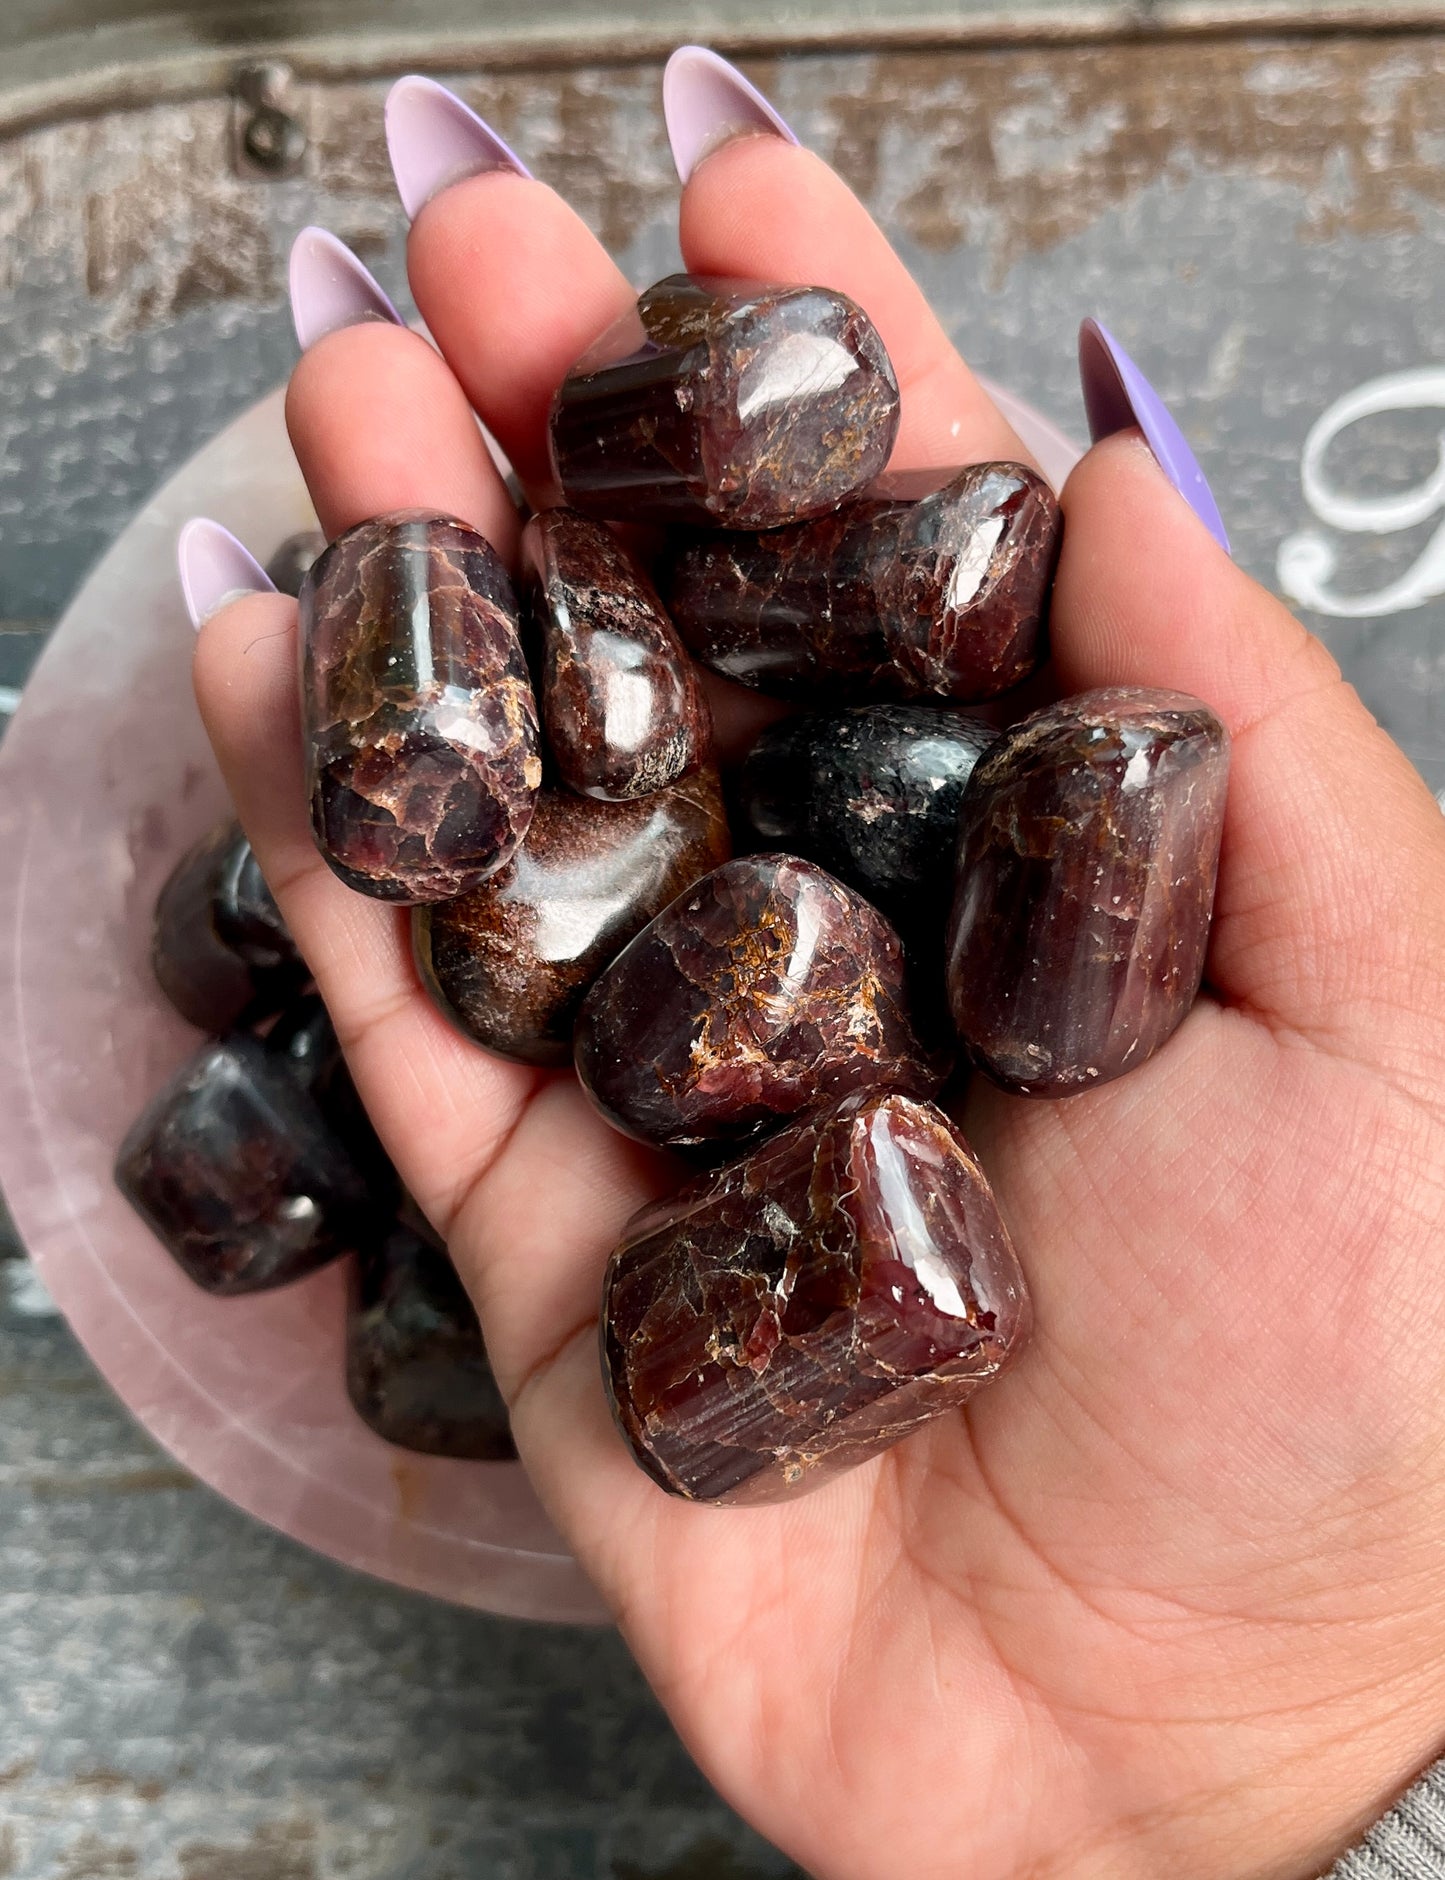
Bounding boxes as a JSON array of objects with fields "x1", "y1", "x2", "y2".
[{"x1": 551, "y1": 274, "x2": 898, "y2": 528}]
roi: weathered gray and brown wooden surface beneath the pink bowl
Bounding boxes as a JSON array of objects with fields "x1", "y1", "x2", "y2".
[{"x1": 0, "y1": 34, "x2": 1445, "y2": 1880}]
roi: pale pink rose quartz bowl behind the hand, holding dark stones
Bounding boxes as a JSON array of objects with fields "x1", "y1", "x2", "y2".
[{"x1": 0, "y1": 387, "x2": 1079, "y2": 1621}]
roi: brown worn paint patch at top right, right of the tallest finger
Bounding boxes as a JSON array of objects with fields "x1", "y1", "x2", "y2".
[{"x1": 804, "y1": 39, "x2": 1445, "y2": 284}]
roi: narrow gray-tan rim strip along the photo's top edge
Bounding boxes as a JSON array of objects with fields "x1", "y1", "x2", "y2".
[{"x1": 0, "y1": 0, "x2": 1441, "y2": 128}]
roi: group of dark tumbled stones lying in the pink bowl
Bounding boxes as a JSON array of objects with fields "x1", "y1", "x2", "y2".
[{"x1": 117, "y1": 538, "x2": 515, "y2": 1461}]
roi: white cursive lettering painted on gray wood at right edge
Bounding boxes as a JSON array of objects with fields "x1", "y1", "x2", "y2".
[{"x1": 1276, "y1": 365, "x2": 1445, "y2": 620}]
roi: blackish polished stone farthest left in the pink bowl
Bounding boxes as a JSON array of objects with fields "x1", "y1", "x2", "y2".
[{"x1": 115, "y1": 1032, "x2": 376, "y2": 1293}]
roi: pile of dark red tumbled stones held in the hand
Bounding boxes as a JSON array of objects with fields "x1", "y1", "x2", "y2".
[{"x1": 115, "y1": 274, "x2": 1227, "y2": 1502}]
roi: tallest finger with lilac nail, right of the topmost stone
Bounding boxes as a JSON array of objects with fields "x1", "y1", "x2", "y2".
[{"x1": 663, "y1": 45, "x2": 1032, "y2": 466}]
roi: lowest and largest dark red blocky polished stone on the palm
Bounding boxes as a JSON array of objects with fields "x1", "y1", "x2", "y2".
[{"x1": 603, "y1": 1092, "x2": 1030, "y2": 1502}]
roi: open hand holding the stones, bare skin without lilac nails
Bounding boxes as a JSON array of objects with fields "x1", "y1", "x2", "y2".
[{"x1": 186, "y1": 73, "x2": 1445, "y2": 1880}]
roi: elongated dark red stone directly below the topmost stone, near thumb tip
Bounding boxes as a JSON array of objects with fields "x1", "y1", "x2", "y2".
[{"x1": 658, "y1": 462, "x2": 1064, "y2": 703}]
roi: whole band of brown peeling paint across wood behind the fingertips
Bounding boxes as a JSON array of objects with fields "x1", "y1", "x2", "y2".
[{"x1": 0, "y1": 38, "x2": 1445, "y2": 340}]
